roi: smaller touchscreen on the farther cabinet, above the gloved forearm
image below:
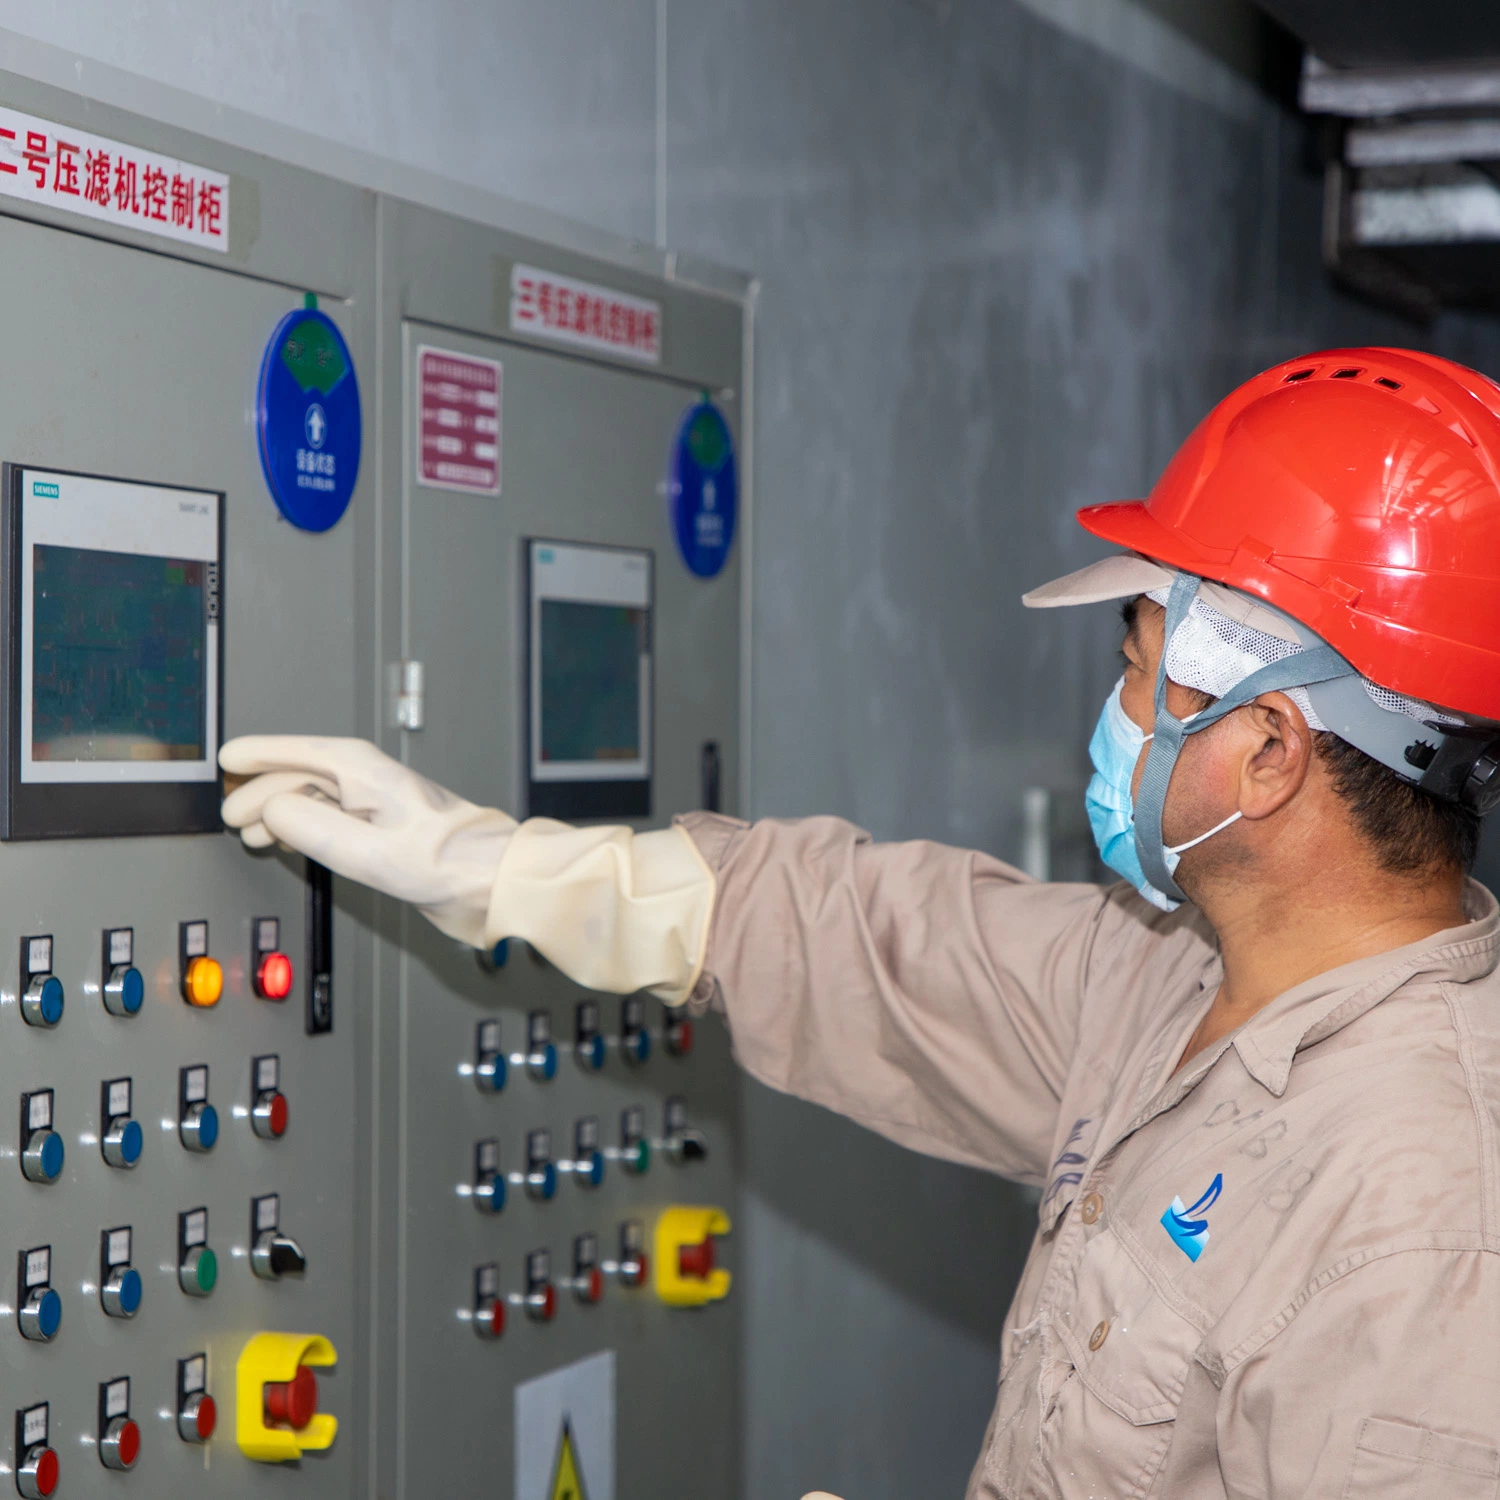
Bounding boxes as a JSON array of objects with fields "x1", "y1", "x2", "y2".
[{"x1": 527, "y1": 542, "x2": 651, "y2": 818}]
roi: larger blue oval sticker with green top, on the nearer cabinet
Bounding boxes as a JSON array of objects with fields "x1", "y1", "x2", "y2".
[{"x1": 255, "y1": 308, "x2": 360, "y2": 531}]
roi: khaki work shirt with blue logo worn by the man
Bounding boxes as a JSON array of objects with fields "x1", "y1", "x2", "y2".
[{"x1": 681, "y1": 815, "x2": 1500, "y2": 1500}]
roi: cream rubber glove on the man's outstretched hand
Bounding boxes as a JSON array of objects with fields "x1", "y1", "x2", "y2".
[{"x1": 219, "y1": 735, "x2": 714, "y2": 1005}]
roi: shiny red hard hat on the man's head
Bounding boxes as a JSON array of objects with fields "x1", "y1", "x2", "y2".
[{"x1": 1079, "y1": 350, "x2": 1500, "y2": 719}]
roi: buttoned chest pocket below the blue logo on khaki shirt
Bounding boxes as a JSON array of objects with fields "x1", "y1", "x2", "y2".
[{"x1": 1059, "y1": 1229, "x2": 1203, "y2": 1427}]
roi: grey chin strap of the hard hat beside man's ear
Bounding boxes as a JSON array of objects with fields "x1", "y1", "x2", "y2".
[{"x1": 1136, "y1": 573, "x2": 1358, "y2": 902}]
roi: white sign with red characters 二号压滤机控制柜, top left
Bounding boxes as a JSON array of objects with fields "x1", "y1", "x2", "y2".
[{"x1": 0, "y1": 107, "x2": 230, "y2": 251}]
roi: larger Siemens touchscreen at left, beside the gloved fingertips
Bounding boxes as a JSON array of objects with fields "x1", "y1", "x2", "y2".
[{"x1": 0, "y1": 465, "x2": 224, "y2": 839}]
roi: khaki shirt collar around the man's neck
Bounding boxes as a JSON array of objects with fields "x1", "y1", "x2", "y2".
[{"x1": 1232, "y1": 881, "x2": 1500, "y2": 1098}]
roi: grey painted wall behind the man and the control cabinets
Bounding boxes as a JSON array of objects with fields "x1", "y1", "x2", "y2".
[{"x1": 0, "y1": 0, "x2": 1500, "y2": 1500}]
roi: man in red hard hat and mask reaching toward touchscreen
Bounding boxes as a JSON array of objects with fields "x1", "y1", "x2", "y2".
[{"x1": 221, "y1": 350, "x2": 1500, "y2": 1500}]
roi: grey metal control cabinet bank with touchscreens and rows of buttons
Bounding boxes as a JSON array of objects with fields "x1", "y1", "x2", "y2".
[{"x1": 0, "y1": 55, "x2": 749, "y2": 1500}]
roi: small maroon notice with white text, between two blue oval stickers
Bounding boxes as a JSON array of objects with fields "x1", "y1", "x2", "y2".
[{"x1": 417, "y1": 345, "x2": 503, "y2": 495}]
